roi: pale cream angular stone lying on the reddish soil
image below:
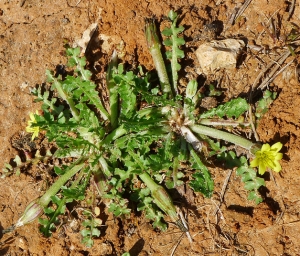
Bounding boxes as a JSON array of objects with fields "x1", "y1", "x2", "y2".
[{"x1": 196, "y1": 39, "x2": 245, "y2": 75}]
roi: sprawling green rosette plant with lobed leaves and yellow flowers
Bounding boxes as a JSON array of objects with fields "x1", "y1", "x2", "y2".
[{"x1": 4, "y1": 11, "x2": 282, "y2": 246}]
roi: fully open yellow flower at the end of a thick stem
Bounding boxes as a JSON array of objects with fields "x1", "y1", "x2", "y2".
[{"x1": 250, "y1": 142, "x2": 283, "y2": 175}]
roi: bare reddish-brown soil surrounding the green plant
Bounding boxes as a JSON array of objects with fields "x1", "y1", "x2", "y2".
[{"x1": 0, "y1": 0, "x2": 300, "y2": 256}]
